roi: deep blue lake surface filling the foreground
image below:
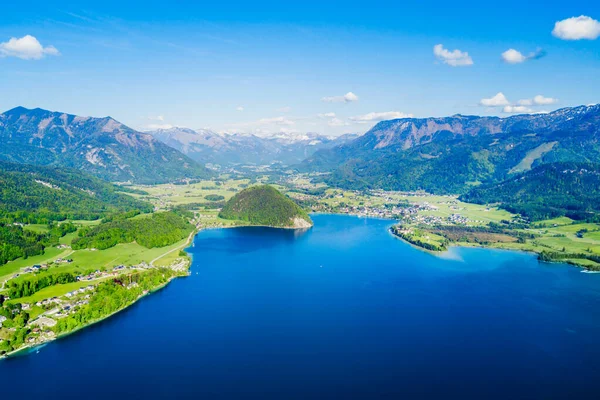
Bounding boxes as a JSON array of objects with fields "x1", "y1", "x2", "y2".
[{"x1": 0, "y1": 215, "x2": 600, "y2": 399}]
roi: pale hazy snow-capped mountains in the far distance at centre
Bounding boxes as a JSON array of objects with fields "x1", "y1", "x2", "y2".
[{"x1": 148, "y1": 128, "x2": 358, "y2": 165}]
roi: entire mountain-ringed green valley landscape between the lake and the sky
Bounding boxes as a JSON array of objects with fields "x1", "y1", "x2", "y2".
[{"x1": 0, "y1": 104, "x2": 600, "y2": 356}]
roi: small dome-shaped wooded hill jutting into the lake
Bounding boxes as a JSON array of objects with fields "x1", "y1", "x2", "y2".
[{"x1": 219, "y1": 185, "x2": 312, "y2": 228}]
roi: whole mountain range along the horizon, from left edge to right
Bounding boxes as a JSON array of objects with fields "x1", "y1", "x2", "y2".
[{"x1": 0, "y1": 105, "x2": 600, "y2": 198}]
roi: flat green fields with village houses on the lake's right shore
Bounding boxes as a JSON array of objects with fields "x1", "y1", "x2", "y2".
[{"x1": 313, "y1": 184, "x2": 600, "y2": 269}]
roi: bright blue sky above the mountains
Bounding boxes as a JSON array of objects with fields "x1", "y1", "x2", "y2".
[{"x1": 0, "y1": 0, "x2": 600, "y2": 135}]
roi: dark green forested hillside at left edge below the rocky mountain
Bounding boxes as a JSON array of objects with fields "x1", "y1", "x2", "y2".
[{"x1": 0, "y1": 162, "x2": 153, "y2": 265}]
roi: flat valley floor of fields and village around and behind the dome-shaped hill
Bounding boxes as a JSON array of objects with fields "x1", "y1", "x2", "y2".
[{"x1": 135, "y1": 169, "x2": 600, "y2": 270}]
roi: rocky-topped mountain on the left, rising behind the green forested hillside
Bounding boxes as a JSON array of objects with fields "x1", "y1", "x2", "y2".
[{"x1": 0, "y1": 107, "x2": 209, "y2": 183}]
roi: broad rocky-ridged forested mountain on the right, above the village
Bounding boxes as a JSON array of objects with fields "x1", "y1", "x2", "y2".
[{"x1": 303, "y1": 105, "x2": 600, "y2": 193}]
